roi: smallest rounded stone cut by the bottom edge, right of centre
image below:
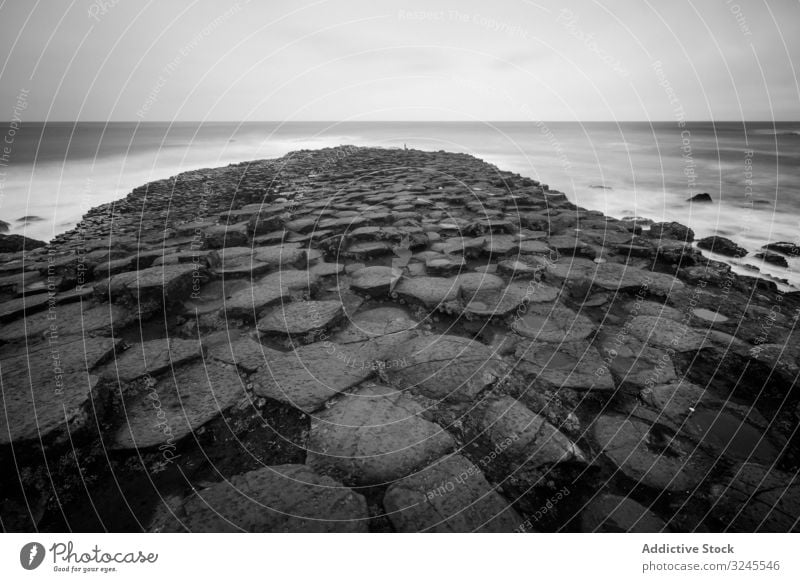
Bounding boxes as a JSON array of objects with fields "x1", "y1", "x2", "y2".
[{"x1": 581, "y1": 495, "x2": 669, "y2": 533}]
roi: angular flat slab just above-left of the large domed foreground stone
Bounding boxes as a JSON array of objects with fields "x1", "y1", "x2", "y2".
[{"x1": 248, "y1": 342, "x2": 377, "y2": 413}]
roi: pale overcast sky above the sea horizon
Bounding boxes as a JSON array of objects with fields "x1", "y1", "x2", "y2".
[{"x1": 0, "y1": 0, "x2": 800, "y2": 122}]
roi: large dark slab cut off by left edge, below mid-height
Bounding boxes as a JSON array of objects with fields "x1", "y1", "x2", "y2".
[{"x1": 0, "y1": 336, "x2": 119, "y2": 445}]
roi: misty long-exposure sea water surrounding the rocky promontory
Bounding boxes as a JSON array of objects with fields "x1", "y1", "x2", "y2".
[{"x1": 0, "y1": 122, "x2": 800, "y2": 286}]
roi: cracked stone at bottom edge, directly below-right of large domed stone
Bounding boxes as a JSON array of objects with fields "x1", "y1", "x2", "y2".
[{"x1": 383, "y1": 455, "x2": 523, "y2": 533}]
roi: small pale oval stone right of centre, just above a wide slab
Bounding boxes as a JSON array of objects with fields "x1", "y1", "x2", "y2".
[{"x1": 511, "y1": 303, "x2": 595, "y2": 343}]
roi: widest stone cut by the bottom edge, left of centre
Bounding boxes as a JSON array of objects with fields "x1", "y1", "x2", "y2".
[{"x1": 168, "y1": 465, "x2": 369, "y2": 533}]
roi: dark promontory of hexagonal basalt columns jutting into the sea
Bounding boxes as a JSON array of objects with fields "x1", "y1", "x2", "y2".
[{"x1": 0, "y1": 146, "x2": 800, "y2": 532}]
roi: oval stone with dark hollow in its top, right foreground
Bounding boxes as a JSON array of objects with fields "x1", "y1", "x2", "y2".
[{"x1": 593, "y1": 415, "x2": 712, "y2": 491}]
